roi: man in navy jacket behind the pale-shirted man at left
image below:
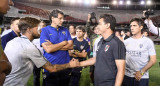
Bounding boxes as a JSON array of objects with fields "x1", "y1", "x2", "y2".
[{"x1": 1, "y1": 17, "x2": 20, "y2": 50}]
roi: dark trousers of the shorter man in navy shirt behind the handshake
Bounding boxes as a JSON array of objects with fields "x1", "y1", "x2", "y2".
[{"x1": 70, "y1": 67, "x2": 82, "y2": 86}]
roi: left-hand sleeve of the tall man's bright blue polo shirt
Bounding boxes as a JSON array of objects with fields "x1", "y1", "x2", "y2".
[{"x1": 40, "y1": 28, "x2": 49, "y2": 45}]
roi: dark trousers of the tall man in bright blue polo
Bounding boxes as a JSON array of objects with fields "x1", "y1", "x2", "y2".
[{"x1": 43, "y1": 69, "x2": 71, "y2": 86}]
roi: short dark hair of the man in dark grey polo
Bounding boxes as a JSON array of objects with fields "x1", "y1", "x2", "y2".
[{"x1": 100, "y1": 14, "x2": 116, "y2": 31}]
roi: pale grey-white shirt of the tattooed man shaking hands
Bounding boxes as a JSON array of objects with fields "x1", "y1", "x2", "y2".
[{"x1": 4, "y1": 36, "x2": 47, "y2": 86}]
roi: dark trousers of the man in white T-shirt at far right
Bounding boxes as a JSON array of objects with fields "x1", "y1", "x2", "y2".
[{"x1": 122, "y1": 76, "x2": 149, "y2": 86}]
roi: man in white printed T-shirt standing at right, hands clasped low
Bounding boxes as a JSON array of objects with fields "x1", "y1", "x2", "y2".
[{"x1": 122, "y1": 18, "x2": 156, "y2": 86}]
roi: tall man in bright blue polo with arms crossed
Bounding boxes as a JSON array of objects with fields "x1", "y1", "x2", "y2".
[{"x1": 40, "y1": 9, "x2": 73, "y2": 86}]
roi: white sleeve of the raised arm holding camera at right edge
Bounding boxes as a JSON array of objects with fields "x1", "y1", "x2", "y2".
[{"x1": 144, "y1": 19, "x2": 160, "y2": 36}]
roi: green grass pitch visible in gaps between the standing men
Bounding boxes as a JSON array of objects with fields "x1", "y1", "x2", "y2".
[{"x1": 27, "y1": 45, "x2": 160, "y2": 86}]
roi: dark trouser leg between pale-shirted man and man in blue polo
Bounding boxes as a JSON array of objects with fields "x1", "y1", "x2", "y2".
[{"x1": 33, "y1": 66, "x2": 41, "y2": 86}]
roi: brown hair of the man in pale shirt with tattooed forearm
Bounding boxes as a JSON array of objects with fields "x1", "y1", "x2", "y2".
[{"x1": 18, "y1": 17, "x2": 40, "y2": 34}]
